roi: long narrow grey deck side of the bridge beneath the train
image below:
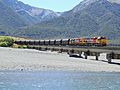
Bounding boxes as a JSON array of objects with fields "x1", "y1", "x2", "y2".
[{"x1": 29, "y1": 45, "x2": 120, "y2": 54}]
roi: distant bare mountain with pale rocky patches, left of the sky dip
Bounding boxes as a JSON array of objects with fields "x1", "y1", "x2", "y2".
[{"x1": 2, "y1": 0, "x2": 60, "y2": 25}]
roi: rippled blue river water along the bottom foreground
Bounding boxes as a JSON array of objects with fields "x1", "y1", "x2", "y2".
[{"x1": 0, "y1": 71, "x2": 120, "y2": 90}]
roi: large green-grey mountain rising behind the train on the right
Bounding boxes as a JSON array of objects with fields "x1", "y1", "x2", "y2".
[{"x1": 18, "y1": 0, "x2": 120, "y2": 40}]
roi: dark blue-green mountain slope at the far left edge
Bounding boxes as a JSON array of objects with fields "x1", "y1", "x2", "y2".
[{"x1": 0, "y1": 0, "x2": 26, "y2": 35}]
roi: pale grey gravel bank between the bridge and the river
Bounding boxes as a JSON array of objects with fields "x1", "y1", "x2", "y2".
[{"x1": 0, "y1": 47, "x2": 120, "y2": 72}]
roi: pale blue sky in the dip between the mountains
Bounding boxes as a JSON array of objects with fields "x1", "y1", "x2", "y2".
[{"x1": 19, "y1": 0, "x2": 83, "y2": 12}]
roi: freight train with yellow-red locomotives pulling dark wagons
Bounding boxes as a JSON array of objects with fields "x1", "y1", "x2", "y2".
[{"x1": 15, "y1": 36, "x2": 107, "y2": 46}]
